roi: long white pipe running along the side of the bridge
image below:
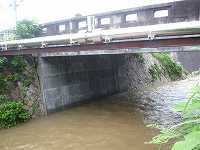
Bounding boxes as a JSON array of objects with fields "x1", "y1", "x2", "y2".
[{"x1": 0, "y1": 21, "x2": 200, "y2": 50}]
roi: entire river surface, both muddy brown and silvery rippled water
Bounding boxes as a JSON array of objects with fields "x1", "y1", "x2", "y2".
[{"x1": 0, "y1": 77, "x2": 199, "y2": 150}]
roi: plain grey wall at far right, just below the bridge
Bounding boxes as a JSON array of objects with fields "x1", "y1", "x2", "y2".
[{"x1": 173, "y1": 52, "x2": 200, "y2": 72}]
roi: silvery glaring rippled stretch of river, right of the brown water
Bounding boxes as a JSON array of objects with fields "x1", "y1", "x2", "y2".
[{"x1": 133, "y1": 75, "x2": 200, "y2": 126}]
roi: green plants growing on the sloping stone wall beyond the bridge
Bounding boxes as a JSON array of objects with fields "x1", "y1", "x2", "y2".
[{"x1": 149, "y1": 53, "x2": 184, "y2": 81}]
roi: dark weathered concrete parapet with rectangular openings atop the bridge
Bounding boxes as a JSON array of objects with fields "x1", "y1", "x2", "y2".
[{"x1": 41, "y1": 0, "x2": 200, "y2": 36}]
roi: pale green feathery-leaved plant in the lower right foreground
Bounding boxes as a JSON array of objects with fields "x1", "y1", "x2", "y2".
[{"x1": 149, "y1": 85, "x2": 200, "y2": 150}]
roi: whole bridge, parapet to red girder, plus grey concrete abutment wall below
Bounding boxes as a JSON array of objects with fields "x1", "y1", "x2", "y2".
[{"x1": 0, "y1": 0, "x2": 200, "y2": 112}]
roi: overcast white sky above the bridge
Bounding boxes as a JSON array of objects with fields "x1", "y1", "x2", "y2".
[{"x1": 0, "y1": 0, "x2": 181, "y2": 30}]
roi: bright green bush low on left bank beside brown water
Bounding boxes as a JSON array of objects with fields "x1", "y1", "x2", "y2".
[{"x1": 0, "y1": 101, "x2": 30, "y2": 128}]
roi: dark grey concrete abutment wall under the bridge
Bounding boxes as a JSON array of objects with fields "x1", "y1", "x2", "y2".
[{"x1": 39, "y1": 55, "x2": 128, "y2": 112}]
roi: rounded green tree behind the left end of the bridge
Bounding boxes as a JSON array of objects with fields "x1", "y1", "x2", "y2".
[{"x1": 16, "y1": 20, "x2": 42, "y2": 39}]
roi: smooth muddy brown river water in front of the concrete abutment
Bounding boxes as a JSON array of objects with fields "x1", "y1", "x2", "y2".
[{"x1": 0, "y1": 96, "x2": 158, "y2": 150}]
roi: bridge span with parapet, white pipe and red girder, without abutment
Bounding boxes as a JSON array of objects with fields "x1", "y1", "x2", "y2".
[{"x1": 0, "y1": 0, "x2": 200, "y2": 57}]
